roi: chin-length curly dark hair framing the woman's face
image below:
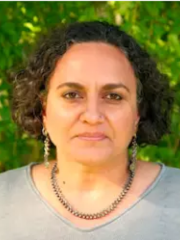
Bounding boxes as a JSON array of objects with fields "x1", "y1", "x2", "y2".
[{"x1": 11, "y1": 21, "x2": 174, "y2": 146}]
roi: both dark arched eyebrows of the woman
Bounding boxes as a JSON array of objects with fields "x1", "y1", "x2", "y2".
[{"x1": 57, "y1": 82, "x2": 130, "y2": 92}]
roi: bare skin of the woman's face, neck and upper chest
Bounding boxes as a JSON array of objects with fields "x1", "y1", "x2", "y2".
[{"x1": 37, "y1": 42, "x2": 159, "y2": 225}]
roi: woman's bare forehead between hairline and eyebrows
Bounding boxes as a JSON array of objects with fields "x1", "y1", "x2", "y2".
[{"x1": 51, "y1": 42, "x2": 136, "y2": 89}]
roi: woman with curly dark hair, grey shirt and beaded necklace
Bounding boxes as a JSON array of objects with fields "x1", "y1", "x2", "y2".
[{"x1": 0, "y1": 21, "x2": 180, "y2": 240}]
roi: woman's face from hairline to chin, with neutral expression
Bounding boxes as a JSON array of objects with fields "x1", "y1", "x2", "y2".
[{"x1": 44, "y1": 42, "x2": 139, "y2": 164}]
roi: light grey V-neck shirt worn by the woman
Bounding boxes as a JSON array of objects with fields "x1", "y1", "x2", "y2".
[{"x1": 0, "y1": 163, "x2": 180, "y2": 240}]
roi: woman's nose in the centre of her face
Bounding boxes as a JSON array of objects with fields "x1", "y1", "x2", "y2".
[{"x1": 80, "y1": 99, "x2": 104, "y2": 125}]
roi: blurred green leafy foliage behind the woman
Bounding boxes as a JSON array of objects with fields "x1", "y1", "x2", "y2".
[{"x1": 0, "y1": 1, "x2": 180, "y2": 172}]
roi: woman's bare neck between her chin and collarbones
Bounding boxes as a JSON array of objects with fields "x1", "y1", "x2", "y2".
[{"x1": 54, "y1": 152, "x2": 129, "y2": 193}]
